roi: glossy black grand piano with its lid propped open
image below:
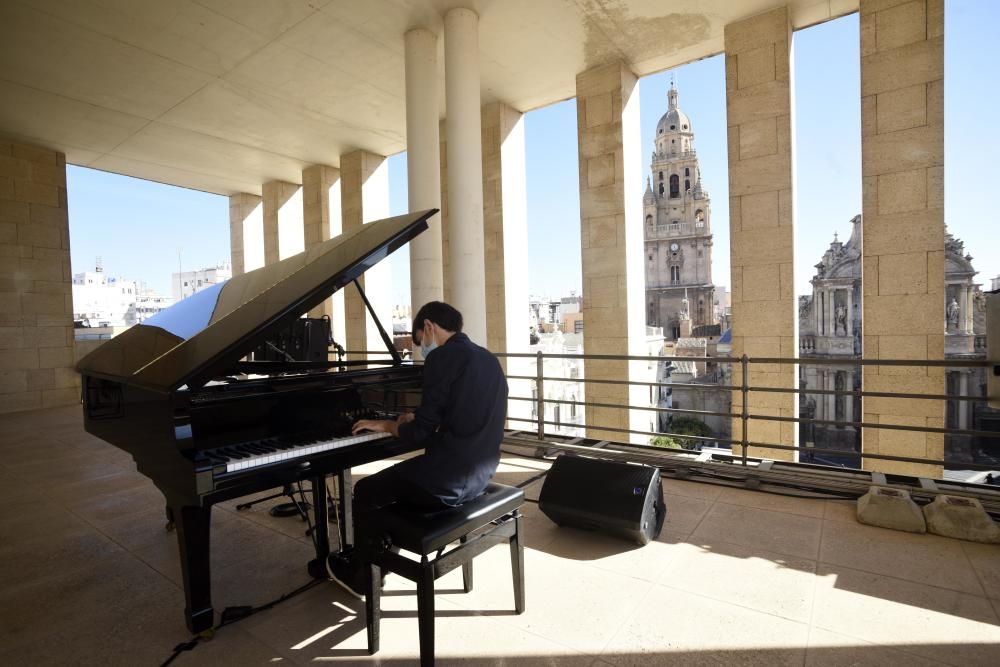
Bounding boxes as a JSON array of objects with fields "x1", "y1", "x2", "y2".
[{"x1": 77, "y1": 209, "x2": 437, "y2": 633}]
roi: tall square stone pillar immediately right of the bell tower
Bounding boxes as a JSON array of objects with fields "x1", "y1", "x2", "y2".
[{"x1": 725, "y1": 7, "x2": 796, "y2": 459}]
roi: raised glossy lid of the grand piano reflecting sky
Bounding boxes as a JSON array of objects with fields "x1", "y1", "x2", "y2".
[{"x1": 77, "y1": 209, "x2": 437, "y2": 392}]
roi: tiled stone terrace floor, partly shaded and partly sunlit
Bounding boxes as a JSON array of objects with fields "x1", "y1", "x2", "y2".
[{"x1": 0, "y1": 408, "x2": 1000, "y2": 666}]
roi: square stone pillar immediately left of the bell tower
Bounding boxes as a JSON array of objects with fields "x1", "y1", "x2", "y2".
[{"x1": 576, "y1": 63, "x2": 649, "y2": 443}]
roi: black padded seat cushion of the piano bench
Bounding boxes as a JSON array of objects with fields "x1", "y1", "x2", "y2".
[{"x1": 370, "y1": 483, "x2": 524, "y2": 555}]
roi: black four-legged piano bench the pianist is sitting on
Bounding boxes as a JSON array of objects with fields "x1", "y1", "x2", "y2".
[{"x1": 365, "y1": 483, "x2": 524, "y2": 665}]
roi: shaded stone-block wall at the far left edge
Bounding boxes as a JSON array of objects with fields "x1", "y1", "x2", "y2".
[{"x1": 0, "y1": 141, "x2": 80, "y2": 414}]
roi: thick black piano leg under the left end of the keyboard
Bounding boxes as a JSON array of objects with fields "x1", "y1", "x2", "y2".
[{"x1": 170, "y1": 506, "x2": 215, "y2": 634}]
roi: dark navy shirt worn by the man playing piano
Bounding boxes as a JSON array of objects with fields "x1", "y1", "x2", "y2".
[{"x1": 396, "y1": 333, "x2": 507, "y2": 505}]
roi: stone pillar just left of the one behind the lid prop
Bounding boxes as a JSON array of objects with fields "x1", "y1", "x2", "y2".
[{"x1": 302, "y1": 164, "x2": 346, "y2": 345}]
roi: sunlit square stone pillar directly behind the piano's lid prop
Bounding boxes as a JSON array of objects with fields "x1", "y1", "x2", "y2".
[{"x1": 340, "y1": 151, "x2": 392, "y2": 359}]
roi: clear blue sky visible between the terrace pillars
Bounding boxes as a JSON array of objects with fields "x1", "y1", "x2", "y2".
[{"x1": 68, "y1": 0, "x2": 1000, "y2": 302}]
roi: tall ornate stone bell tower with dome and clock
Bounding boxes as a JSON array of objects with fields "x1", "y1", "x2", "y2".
[{"x1": 643, "y1": 85, "x2": 715, "y2": 340}]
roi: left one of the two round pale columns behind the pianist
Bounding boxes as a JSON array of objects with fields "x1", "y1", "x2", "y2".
[{"x1": 405, "y1": 28, "x2": 444, "y2": 318}]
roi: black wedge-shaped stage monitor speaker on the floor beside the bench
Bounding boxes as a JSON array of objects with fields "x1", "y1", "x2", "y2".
[{"x1": 538, "y1": 454, "x2": 667, "y2": 544}]
